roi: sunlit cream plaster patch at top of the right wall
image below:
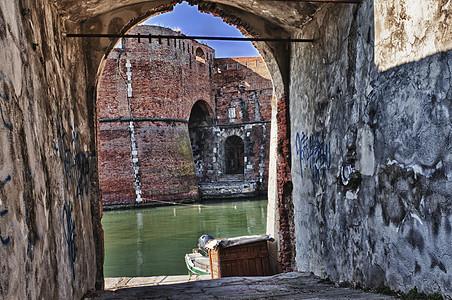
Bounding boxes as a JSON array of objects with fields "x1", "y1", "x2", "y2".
[{"x1": 374, "y1": 0, "x2": 452, "y2": 70}]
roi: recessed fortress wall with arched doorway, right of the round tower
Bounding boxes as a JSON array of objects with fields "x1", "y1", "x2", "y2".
[{"x1": 191, "y1": 57, "x2": 273, "y2": 198}]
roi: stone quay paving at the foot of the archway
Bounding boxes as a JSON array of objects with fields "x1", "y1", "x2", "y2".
[{"x1": 85, "y1": 272, "x2": 393, "y2": 299}]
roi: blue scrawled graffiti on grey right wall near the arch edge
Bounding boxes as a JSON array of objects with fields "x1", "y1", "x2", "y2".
[{"x1": 295, "y1": 132, "x2": 331, "y2": 183}]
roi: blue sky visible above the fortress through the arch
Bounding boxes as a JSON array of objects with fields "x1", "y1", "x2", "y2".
[{"x1": 144, "y1": 2, "x2": 259, "y2": 58}]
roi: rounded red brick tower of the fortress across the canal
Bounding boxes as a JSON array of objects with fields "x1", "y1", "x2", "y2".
[{"x1": 98, "y1": 26, "x2": 214, "y2": 204}]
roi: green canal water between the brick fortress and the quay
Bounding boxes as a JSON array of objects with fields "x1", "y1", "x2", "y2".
[{"x1": 102, "y1": 200, "x2": 267, "y2": 277}]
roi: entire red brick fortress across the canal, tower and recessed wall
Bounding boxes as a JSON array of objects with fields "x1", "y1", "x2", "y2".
[{"x1": 98, "y1": 26, "x2": 272, "y2": 205}]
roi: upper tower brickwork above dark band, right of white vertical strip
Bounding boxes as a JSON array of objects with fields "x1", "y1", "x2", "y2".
[{"x1": 123, "y1": 26, "x2": 214, "y2": 120}]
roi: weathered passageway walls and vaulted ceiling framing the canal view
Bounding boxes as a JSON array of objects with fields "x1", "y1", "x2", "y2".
[{"x1": 0, "y1": 0, "x2": 452, "y2": 299}]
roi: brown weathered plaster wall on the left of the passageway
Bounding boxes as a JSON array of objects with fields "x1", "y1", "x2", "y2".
[{"x1": 0, "y1": 0, "x2": 101, "y2": 299}]
